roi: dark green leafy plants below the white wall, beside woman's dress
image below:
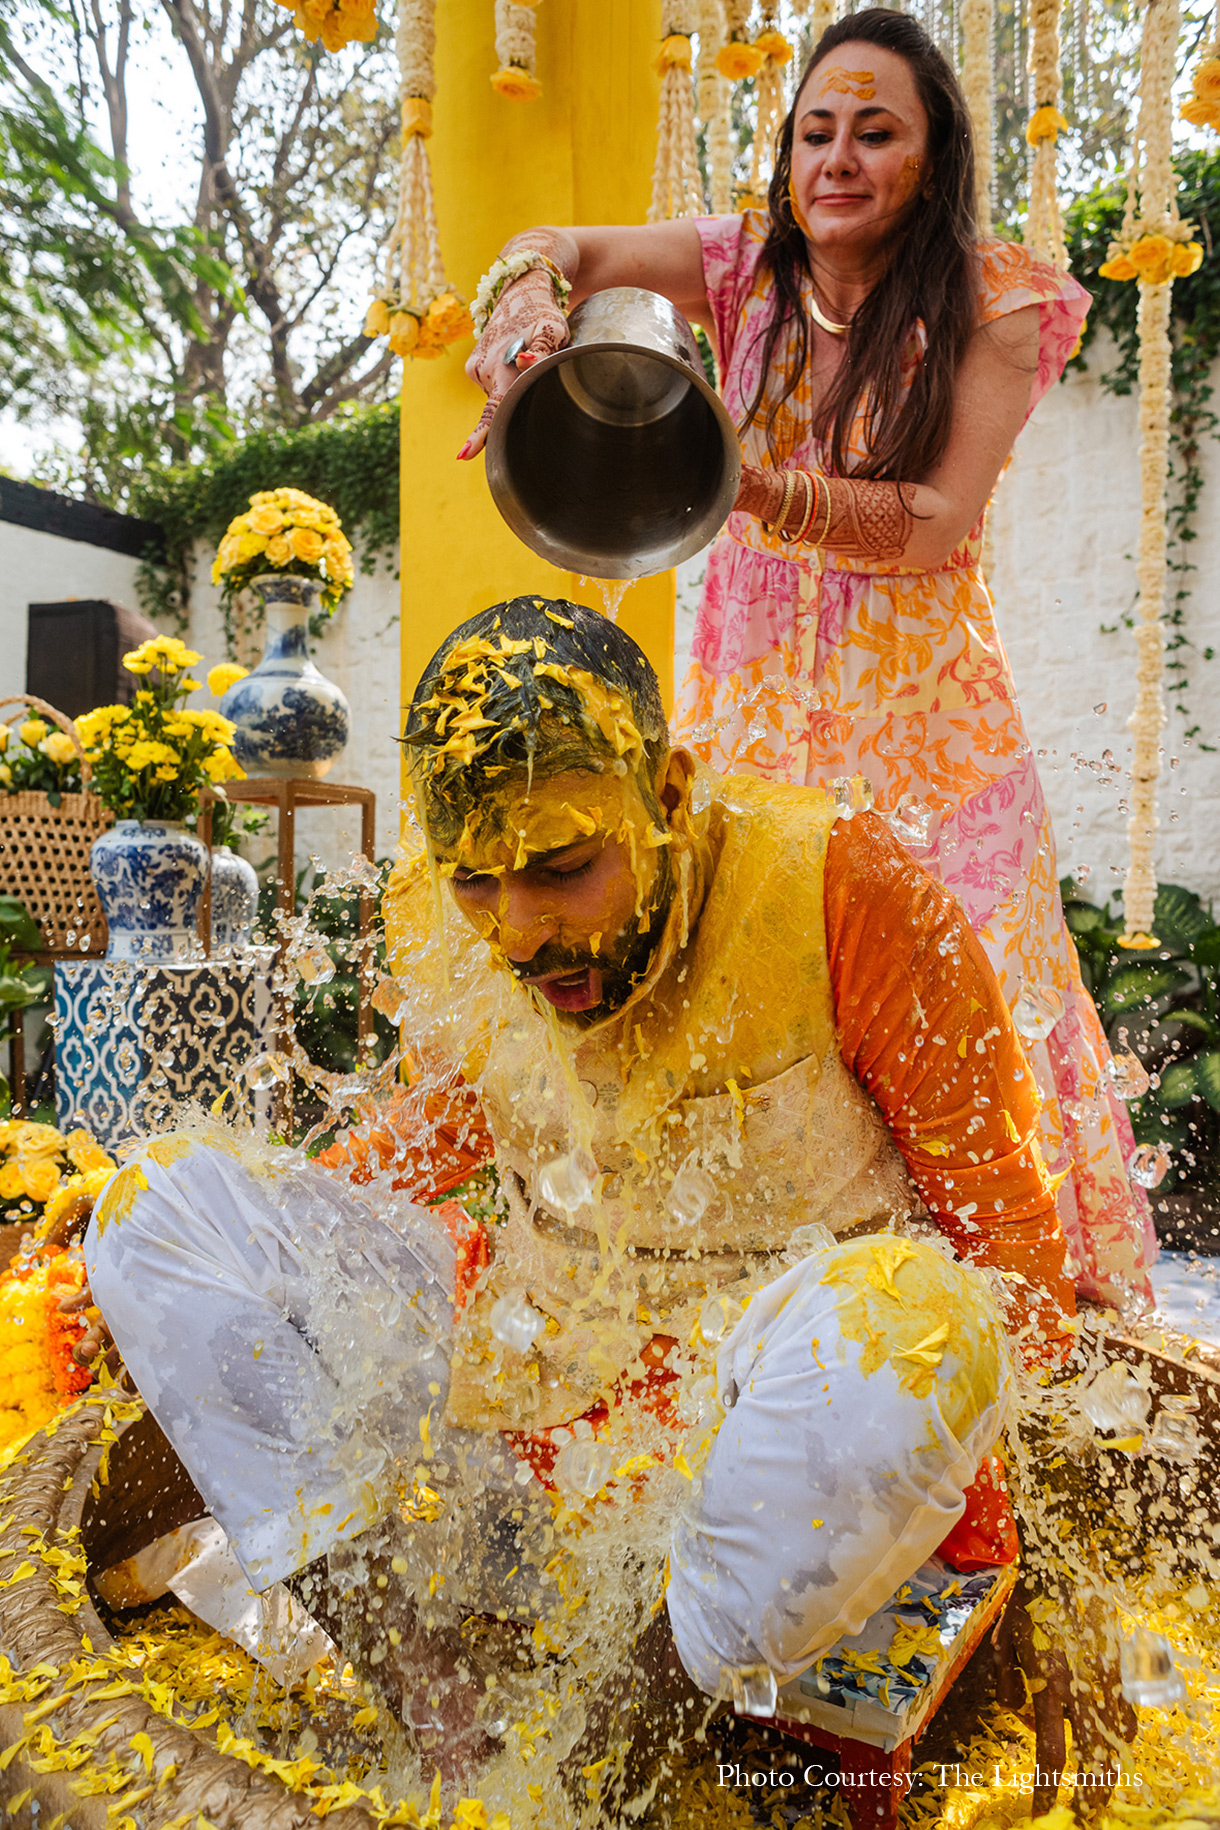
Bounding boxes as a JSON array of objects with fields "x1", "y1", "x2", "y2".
[{"x1": 1059, "y1": 877, "x2": 1220, "y2": 1193}]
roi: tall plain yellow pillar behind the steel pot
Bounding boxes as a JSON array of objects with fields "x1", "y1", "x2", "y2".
[{"x1": 401, "y1": 0, "x2": 673, "y2": 753}]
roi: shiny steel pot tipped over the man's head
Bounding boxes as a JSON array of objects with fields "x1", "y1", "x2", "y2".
[{"x1": 487, "y1": 285, "x2": 741, "y2": 578}]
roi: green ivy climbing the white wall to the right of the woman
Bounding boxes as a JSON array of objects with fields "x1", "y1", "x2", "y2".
[{"x1": 1066, "y1": 152, "x2": 1220, "y2": 748}]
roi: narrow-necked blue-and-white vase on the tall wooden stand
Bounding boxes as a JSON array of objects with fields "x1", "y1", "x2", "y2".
[{"x1": 219, "y1": 573, "x2": 351, "y2": 776}]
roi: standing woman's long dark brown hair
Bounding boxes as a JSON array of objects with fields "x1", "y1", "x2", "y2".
[{"x1": 741, "y1": 7, "x2": 979, "y2": 483}]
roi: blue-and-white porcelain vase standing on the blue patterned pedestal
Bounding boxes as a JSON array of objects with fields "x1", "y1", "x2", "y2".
[{"x1": 90, "y1": 820, "x2": 209, "y2": 964}]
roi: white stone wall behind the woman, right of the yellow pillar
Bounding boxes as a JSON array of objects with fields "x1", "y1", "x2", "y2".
[{"x1": 675, "y1": 339, "x2": 1220, "y2": 913}]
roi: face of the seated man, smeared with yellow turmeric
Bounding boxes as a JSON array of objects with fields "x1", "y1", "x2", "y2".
[{"x1": 435, "y1": 765, "x2": 673, "y2": 1019}]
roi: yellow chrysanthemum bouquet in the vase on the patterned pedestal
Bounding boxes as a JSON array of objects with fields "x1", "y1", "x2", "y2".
[{"x1": 77, "y1": 635, "x2": 245, "y2": 820}]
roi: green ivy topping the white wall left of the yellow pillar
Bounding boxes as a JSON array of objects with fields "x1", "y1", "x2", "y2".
[{"x1": 130, "y1": 404, "x2": 399, "y2": 628}]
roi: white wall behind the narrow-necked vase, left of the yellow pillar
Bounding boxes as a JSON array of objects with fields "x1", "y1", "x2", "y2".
[{"x1": 187, "y1": 545, "x2": 402, "y2": 869}]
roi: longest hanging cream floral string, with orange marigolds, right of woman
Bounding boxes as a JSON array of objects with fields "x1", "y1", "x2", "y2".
[{"x1": 1103, "y1": 0, "x2": 1180, "y2": 948}]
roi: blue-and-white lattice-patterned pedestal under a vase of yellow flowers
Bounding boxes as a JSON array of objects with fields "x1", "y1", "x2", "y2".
[{"x1": 55, "y1": 948, "x2": 274, "y2": 1149}]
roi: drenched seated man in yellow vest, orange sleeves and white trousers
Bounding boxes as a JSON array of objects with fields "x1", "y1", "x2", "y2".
[{"x1": 86, "y1": 598, "x2": 1074, "y2": 1800}]
